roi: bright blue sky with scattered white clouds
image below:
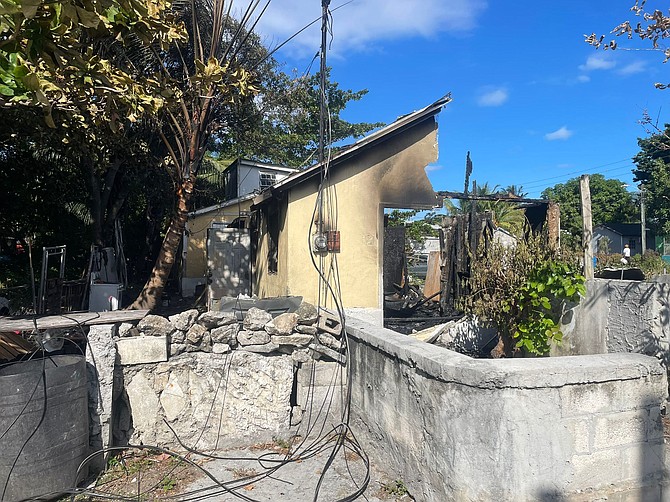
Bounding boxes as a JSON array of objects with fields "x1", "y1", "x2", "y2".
[{"x1": 258, "y1": 0, "x2": 670, "y2": 197}]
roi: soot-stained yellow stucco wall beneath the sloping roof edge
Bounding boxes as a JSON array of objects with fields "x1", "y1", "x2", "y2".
[{"x1": 255, "y1": 118, "x2": 437, "y2": 308}]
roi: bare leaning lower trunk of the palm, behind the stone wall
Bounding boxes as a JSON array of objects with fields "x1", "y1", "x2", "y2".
[{"x1": 129, "y1": 178, "x2": 194, "y2": 310}]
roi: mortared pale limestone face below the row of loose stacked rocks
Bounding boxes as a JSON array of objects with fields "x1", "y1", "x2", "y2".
[{"x1": 116, "y1": 351, "x2": 293, "y2": 450}]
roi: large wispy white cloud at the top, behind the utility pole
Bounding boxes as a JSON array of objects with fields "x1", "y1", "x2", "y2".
[{"x1": 252, "y1": 0, "x2": 487, "y2": 56}]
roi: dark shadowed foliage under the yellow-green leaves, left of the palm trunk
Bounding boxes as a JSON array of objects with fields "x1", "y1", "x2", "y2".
[{"x1": 0, "y1": 103, "x2": 172, "y2": 280}]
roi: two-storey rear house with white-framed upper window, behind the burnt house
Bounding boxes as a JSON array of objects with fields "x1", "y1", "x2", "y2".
[{"x1": 180, "y1": 159, "x2": 297, "y2": 296}]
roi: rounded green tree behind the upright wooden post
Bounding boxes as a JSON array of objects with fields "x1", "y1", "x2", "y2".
[{"x1": 542, "y1": 174, "x2": 640, "y2": 238}]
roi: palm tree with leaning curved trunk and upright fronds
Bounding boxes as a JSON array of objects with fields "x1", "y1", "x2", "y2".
[{"x1": 123, "y1": 0, "x2": 258, "y2": 309}]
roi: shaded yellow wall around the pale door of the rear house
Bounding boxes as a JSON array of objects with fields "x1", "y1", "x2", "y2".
[{"x1": 182, "y1": 199, "x2": 252, "y2": 279}]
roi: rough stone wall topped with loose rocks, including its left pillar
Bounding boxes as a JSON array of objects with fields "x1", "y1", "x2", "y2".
[{"x1": 87, "y1": 303, "x2": 343, "y2": 458}]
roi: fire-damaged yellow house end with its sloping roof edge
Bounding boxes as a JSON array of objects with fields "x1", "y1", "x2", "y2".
[{"x1": 252, "y1": 96, "x2": 450, "y2": 311}]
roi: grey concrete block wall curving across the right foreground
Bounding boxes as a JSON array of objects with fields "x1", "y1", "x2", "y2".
[{"x1": 347, "y1": 319, "x2": 667, "y2": 502}]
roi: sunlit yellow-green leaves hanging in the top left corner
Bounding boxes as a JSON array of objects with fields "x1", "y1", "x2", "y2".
[{"x1": 0, "y1": 0, "x2": 186, "y2": 127}]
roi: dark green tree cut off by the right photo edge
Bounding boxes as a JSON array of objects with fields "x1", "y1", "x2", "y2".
[{"x1": 633, "y1": 126, "x2": 670, "y2": 234}]
